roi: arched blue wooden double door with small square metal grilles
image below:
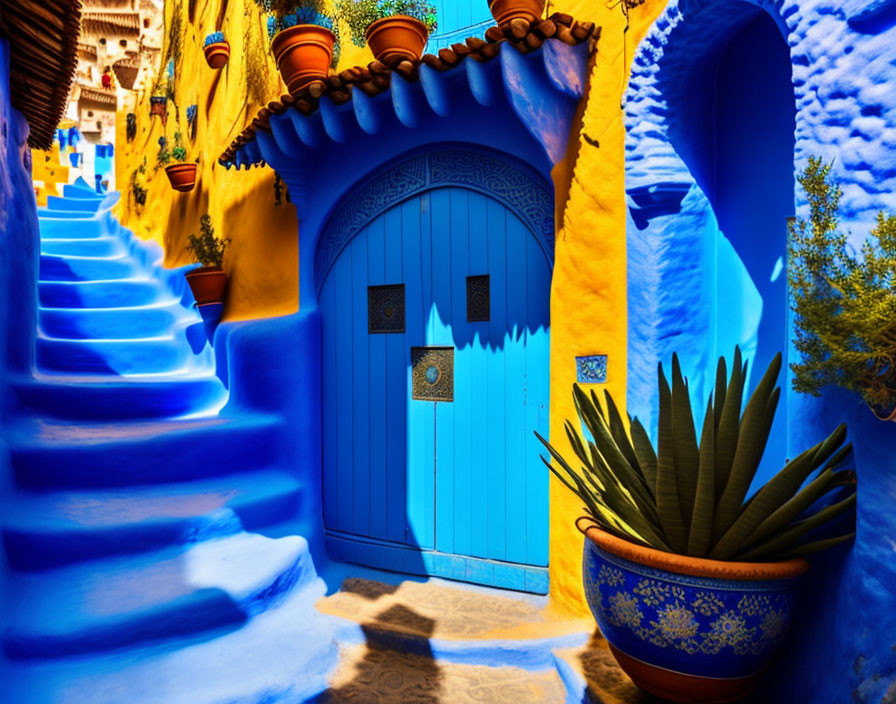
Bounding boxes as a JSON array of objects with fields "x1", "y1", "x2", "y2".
[{"x1": 320, "y1": 187, "x2": 551, "y2": 591}]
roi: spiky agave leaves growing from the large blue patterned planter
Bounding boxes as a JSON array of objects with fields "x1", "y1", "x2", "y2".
[{"x1": 536, "y1": 349, "x2": 856, "y2": 562}]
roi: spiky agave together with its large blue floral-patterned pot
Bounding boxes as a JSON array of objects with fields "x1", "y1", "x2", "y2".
[{"x1": 541, "y1": 350, "x2": 856, "y2": 703}]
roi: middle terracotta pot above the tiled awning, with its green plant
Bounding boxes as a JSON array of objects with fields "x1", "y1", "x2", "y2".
[{"x1": 336, "y1": 0, "x2": 438, "y2": 66}]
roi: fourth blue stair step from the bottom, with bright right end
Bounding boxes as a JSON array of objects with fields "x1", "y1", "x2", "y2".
[{"x1": 11, "y1": 373, "x2": 227, "y2": 420}]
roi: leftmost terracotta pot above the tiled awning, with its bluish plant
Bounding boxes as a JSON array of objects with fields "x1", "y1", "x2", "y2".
[{"x1": 255, "y1": 0, "x2": 337, "y2": 93}]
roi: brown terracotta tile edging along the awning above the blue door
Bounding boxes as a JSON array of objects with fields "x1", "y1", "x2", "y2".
[{"x1": 218, "y1": 13, "x2": 600, "y2": 165}]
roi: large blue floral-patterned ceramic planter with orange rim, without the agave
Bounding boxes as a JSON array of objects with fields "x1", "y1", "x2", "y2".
[{"x1": 577, "y1": 518, "x2": 809, "y2": 704}]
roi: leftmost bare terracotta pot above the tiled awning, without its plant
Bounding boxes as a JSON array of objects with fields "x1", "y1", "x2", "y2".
[{"x1": 271, "y1": 24, "x2": 336, "y2": 93}]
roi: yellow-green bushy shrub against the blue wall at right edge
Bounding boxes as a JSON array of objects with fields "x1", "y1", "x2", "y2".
[{"x1": 788, "y1": 158, "x2": 896, "y2": 413}]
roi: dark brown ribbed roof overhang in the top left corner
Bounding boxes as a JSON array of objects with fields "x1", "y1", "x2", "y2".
[{"x1": 0, "y1": 0, "x2": 81, "y2": 149}]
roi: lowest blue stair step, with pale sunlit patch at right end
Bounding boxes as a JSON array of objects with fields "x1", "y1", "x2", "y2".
[{"x1": 3, "y1": 533, "x2": 316, "y2": 659}]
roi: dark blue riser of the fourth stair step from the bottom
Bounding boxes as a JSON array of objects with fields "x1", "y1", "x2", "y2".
[{"x1": 16, "y1": 379, "x2": 224, "y2": 420}]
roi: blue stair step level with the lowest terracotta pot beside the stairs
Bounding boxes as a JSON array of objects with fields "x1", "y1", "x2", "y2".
[{"x1": 38, "y1": 279, "x2": 164, "y2": 308}]
